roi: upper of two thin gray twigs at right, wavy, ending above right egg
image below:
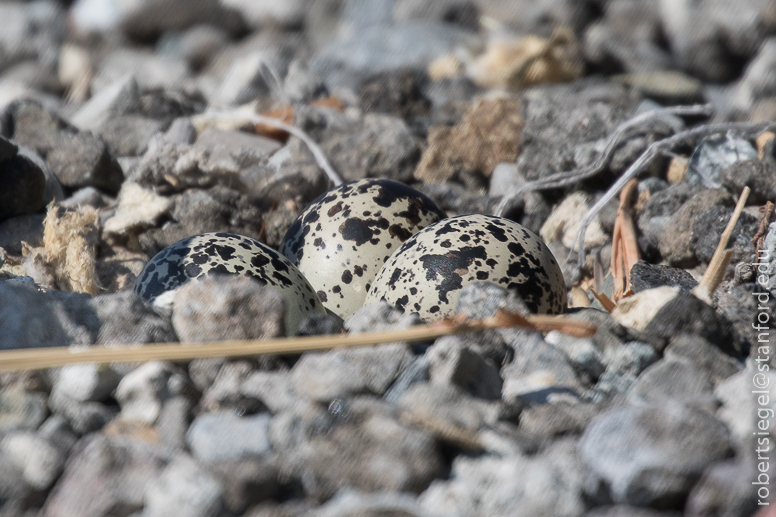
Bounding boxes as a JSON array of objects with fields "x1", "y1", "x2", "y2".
[{"x1": 494, "y1": 104, "x2": 712, "y2": 216}]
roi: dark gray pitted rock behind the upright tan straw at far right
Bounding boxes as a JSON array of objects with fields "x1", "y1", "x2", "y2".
[{"x1": 690, "y1": 206, "x2": 758, "y2": 264}]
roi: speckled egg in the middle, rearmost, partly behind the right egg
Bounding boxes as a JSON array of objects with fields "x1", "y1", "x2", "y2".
[{"x1": 279, "y1": 179, "x2": 445, "y2": 318}]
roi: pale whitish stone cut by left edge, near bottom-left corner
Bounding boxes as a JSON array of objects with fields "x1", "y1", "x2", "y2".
[{"x1": 0, "y1": 431, "x2": 66, "y2": 490}]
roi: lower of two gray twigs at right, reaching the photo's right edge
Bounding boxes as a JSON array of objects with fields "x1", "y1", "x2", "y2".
[{"x1": 567, "y1": 122, "x2": 774, "y2": 268}]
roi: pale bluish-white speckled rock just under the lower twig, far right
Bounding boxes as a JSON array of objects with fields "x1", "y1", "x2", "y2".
[{"x1": 685, "y1": 134, "x2": 757, "y2": 188}]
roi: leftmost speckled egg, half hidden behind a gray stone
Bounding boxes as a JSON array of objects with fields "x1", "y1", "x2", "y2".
[{"x1": 135, "y1": 233, "x2": 326, "y2": 335}]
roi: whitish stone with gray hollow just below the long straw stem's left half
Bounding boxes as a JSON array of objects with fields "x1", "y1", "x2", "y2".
[{"x1": 115, "y1": 361, "x2": 181, "y2": 425}]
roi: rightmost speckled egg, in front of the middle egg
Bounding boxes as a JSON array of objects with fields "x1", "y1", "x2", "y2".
[{"x1": 365, "y1": 215, "x2": 566, "y2": 320}]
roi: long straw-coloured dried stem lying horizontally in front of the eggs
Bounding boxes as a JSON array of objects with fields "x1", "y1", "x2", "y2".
[{"x1": 0, "y1": 312, "x2": 596, "y2": 372}]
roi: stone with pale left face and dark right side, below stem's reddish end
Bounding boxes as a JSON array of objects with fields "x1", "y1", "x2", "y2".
[{"x1": 426, "y1": 336, "x2": 502, "y2": 400}]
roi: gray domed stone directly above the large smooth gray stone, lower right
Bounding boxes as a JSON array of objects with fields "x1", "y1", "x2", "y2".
[{"x1": 628, "y1": 358, "x2": 716, "y2": 413}]
